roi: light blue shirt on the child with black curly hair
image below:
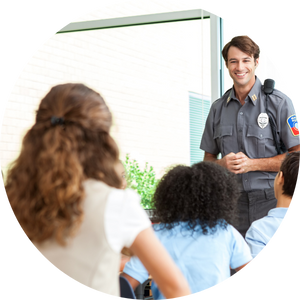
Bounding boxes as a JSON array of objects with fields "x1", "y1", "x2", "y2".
[{"x1": 123, "y1": 222, "x2": 252, "y2": 300}]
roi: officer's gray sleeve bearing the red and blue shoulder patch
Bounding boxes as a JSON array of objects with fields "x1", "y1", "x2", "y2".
[{"x1": 277, "y1": 95, "x2": 300, "y2": 149}]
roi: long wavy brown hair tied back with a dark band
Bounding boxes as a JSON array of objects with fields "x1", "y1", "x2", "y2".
[{"x1": 3, "y1": 84, "x2": 121, "y2": 245}]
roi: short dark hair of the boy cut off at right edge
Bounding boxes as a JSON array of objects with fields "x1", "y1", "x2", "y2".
[{"x1": 280, "y1": 151, "x2": 300, "y2": 199}]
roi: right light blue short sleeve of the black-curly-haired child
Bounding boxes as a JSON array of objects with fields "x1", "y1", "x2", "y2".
[{"x1": 230, "y1": 226, "x2": 252, "y2": 269}]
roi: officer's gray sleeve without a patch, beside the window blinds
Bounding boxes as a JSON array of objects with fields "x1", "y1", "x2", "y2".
[{"x1": 200, "y1": 105, "x2": 220, "y2": 155}]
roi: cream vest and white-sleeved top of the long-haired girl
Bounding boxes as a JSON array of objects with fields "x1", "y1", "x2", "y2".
[{"x1": 31, "y1": 179, "x2": 151, "y2": 299}]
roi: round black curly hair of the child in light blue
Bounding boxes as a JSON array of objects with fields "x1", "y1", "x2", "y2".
[{"x1": 153, "y1": 162, "x2": 238, "y2": 234}]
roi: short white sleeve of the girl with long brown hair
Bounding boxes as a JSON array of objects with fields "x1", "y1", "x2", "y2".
[{"x1": 104, "y1": 189, "x2": 151, "y2": 253}]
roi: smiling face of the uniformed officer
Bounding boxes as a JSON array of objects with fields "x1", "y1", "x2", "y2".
[{"x1": 227, "y1": 46, "x2": 258, "y2": 88}]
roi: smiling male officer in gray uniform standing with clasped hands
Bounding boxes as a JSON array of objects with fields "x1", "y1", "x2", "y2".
[{"x1": 200, "y1": 34, "x2": 300, "y2": 237}]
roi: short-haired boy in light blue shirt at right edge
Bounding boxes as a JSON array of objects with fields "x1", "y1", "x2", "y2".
[{"x1": 245, "y1": 151, "x2": 300, "y2": 261}]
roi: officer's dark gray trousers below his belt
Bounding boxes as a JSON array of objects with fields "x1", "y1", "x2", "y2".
[{"x1": 231, "y1": 188, "x2": 277, "y2": 278}]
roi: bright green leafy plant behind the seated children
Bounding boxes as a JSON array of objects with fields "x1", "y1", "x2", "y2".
[{"x1": 123, "y1": 154, "x2": 159, "y2": 209}]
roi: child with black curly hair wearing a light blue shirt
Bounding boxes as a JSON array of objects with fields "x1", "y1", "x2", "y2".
[{"x1": 122, "y1": 162, "x2": 252, "y2": 300}]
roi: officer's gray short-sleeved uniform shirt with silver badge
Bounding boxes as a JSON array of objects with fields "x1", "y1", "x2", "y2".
[{"x1": 200, "y1": 76, "x2": 300, "y2": 192}]
